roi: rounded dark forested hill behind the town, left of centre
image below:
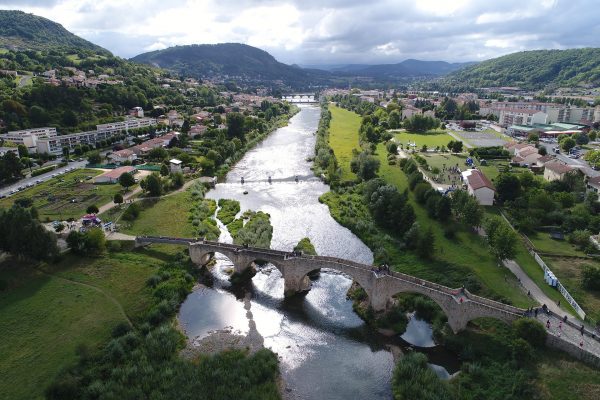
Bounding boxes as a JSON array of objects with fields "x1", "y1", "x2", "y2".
[{"x1": 131, "y1": 43, "x2": 329, "y2": 86}]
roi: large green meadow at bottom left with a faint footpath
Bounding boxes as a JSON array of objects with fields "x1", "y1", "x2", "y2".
[{"x1": 0, "y1": 250, "x2": 164, "y2": 400}]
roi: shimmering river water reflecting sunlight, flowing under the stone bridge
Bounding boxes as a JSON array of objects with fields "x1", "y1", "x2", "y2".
[{"x1": 179, "y1": 106, "x2": 458, "y2": 400}]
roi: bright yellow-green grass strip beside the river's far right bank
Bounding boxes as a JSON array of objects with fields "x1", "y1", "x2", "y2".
[{"x1": 329, "y1": 105, "x2": 360, "y2": 181}]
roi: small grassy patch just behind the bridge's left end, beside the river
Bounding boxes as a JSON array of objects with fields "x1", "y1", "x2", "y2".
[{"x1": 120, "y1": 191, "x2": 197, "y2": 237}]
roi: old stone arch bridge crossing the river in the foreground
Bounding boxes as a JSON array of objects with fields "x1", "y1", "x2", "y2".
[{"x1": 135, "y1": 236, "x2": 525, "y2": 332}]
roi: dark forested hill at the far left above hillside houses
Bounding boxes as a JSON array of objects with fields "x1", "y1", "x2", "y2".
[{"x1": 0, "y1": 10, "x2": 110, "y2": 55}]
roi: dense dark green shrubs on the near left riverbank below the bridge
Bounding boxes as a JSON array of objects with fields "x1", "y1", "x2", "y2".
[{"x1": 46, "y1": 253, "x2": 279, "y2": 400}]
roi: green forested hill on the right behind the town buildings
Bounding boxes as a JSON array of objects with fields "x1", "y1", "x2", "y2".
[{"x1": 445, "y1": 48, "x2": 600, "y2": 89}]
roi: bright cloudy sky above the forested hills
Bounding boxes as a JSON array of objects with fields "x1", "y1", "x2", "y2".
[{"x1": 0, "y1": 0, "x2": 600, "y2": 64}]
